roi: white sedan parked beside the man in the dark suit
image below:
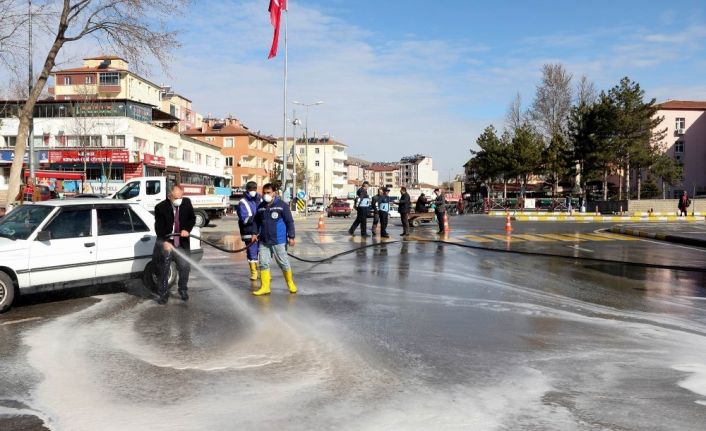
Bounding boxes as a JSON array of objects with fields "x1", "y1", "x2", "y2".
[{"x1": 0, "y1": 199, "x2": 203, "y2": 312}]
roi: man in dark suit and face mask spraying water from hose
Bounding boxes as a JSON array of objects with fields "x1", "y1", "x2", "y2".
[{"x1": 153, "y1": 185, "x2": 196, "y2": 304}]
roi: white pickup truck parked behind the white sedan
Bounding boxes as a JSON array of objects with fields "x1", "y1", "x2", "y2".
[{"x1": 110, "y1": 177, "x2": 229, "y2": 227}]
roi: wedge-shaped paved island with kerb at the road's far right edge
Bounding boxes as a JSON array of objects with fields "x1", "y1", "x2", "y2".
[{"x1": 610, "y1": 222, "x2": 706, "y2": 248}]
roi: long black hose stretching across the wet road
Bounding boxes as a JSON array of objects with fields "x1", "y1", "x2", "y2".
[{"x1": 165, "y1": 233, "x2": 706, "y2": 272}]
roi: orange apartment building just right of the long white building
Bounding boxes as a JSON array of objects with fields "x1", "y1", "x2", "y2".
[{"x1": 184, "y1": 118, "x2": 277, "y2": 187}]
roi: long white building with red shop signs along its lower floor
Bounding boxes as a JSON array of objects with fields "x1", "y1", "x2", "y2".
[{"x1": 0, "y1": 99, "x2": 226, "y2": 193}]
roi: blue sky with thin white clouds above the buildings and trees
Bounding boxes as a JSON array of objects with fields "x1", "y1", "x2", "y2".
[{"x1": 57, "y1": 0, "x2": 706, "y2": 179}]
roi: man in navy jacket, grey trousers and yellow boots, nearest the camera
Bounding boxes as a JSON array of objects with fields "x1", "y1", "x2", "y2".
[{"x1": 253, "y1": 184, "x2": 297, "y2": 296}]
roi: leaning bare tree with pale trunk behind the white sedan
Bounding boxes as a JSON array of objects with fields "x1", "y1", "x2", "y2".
[{"x1": 0, "y1": 0, "x2": 188, "y2": 207}]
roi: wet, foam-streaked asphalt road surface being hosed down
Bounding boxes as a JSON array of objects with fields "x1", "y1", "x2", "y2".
[{"x1": 0, "y1": 216, "x2": 706, "y2": 430}]
